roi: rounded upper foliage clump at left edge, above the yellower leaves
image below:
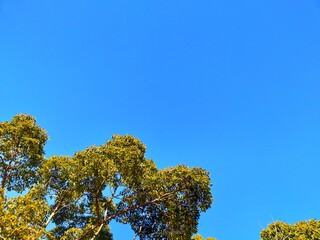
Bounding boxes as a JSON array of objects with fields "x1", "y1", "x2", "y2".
[{"x1": 0, "y1": 114, "x2": 48, "y2": 192}]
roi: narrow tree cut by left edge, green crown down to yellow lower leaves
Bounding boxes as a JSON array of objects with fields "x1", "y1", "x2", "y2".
[{"x1": 0, "y1": 115, "x2": 49, "y2": 239}]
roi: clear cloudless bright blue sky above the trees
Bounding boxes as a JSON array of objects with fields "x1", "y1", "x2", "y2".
[{"x1": 0, "y1": 0, "x2": 320, "y2": 240}]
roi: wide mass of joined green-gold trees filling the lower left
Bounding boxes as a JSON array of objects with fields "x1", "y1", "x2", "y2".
[{"x1": 0, "y1": 114, "x2": 212, "y2": 240}]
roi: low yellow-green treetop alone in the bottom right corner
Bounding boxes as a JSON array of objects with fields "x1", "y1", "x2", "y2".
[{"x1": 260, "y1": 220, "x2": 320, "y2": 240}]
